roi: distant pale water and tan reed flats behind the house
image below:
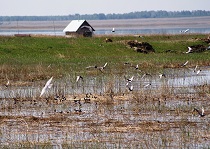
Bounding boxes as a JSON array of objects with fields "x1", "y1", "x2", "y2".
[{"x1": 0, "y1": 17, "x2": 210, "y2": 36}]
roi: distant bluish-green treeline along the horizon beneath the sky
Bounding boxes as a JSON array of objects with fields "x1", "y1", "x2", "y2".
[{"x1": 0, "y1": 10, "x2": 210, "y2": 22}]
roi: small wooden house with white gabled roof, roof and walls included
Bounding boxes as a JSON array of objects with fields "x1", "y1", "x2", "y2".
[{"x1": 63, "y1": 20, "x2": 95, "y2": 37}]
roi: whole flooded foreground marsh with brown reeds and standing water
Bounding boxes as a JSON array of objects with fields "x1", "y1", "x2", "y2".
[{"x1": 0, "y1": 67, "x2": 210, "y2": 148}]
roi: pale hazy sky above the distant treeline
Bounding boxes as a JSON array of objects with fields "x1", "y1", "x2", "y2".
[{"x1": 0, "y1": 0, "x2": 210, "y2": 16}]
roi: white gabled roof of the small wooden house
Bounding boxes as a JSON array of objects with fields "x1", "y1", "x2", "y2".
[{"x1": 63, "y1": 20, "x2": 94, "y2": 32}]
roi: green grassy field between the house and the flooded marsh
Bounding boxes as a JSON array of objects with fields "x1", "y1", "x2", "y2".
[{"x1": 0, "y1": 34, "x2": 210, "y2": 79}]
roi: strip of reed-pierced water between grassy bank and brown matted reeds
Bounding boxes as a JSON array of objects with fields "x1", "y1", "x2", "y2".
[{"x1": 0, "y1": 67, "x2": 210, "y2": 98}]
